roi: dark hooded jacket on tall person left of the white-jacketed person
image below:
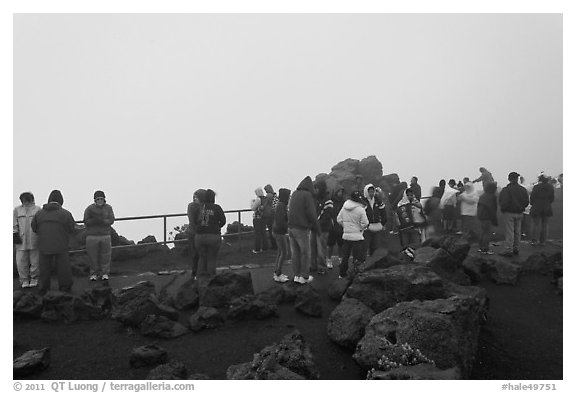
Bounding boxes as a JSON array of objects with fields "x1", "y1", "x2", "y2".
[{"x1": 288, "y1": 176, "x2": 321, "y2": 233}]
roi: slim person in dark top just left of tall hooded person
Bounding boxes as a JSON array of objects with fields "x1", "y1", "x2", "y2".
[{"x1": 272, "y1": 188, "x2": 291, "y2": 282}]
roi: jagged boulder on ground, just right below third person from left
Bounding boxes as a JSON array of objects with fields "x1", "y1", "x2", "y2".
[{"x1": 111, "y1": 281, "x2": 179, "y2": 326}]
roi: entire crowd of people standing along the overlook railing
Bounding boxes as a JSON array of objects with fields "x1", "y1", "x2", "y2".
[{"x1": 13, "y1": 168, "x2": 554, "y2": 294}]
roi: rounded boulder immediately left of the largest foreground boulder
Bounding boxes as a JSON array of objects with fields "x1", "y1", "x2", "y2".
[{"x1": 327, "y1": 298, "x2": 374, "y2": 350}]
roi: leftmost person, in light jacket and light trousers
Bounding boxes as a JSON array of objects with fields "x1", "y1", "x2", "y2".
[{"x1": 12, "y1": 192, "x2": 40, "y2": 288}]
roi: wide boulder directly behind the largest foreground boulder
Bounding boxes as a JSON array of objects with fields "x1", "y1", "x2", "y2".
[{"x1": 344, "y1": 264, "x2": 446, "y2": 313}]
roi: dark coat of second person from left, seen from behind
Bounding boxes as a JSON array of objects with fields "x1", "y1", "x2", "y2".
[{"x1": 31, "y1": 203, "x2": 75, "y2": 254}]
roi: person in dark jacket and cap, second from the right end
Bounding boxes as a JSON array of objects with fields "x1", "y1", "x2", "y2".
[{"x1": 498, "y1": 172, "x2": 529, "y2": 257}]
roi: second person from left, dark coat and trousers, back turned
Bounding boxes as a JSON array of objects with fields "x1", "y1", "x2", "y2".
[{"x1": 31, "y1": 190, "x2": 75, "y2": 295}]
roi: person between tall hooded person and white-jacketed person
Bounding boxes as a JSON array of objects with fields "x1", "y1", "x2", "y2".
[{"x1": 310, "y1": 180, "x2": 334, "y2": 275}]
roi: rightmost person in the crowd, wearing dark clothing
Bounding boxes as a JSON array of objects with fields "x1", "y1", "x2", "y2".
[{"x1": 530, "y1": 175, "x2": 554, "y2": 246}]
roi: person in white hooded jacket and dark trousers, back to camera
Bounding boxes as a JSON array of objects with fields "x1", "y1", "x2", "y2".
[{"x1": 336, "y1": 191, "x2": 369, "y2": 278}]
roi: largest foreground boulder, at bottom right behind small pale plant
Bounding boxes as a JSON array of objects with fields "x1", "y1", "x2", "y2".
[{"x1": 354, "y1": 296, "x2": 485, "y2": 378}]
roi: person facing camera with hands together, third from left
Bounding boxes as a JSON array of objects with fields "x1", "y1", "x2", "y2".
[{"x1": 84, "y1": 190, "x2": 115, "y2": 281}]
